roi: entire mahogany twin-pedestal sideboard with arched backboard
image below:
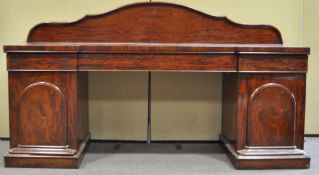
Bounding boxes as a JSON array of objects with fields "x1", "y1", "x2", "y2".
[{"x1": 4, "y1": 2, "x2": 310, "y2": 169}]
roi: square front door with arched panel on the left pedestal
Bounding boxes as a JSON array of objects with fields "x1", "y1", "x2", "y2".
[{"x1": 9, "y1": 72, "x2": 75, "y2": 147}]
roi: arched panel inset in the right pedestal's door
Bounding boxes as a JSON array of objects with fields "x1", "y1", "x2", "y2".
[{"x1": 247, "y1": 81, "x2": 296, "y2": 146}]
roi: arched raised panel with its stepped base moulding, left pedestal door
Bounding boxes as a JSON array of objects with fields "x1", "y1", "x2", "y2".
[{"x1": 10, "y1": 81, "x2": 76, "y2": 155}]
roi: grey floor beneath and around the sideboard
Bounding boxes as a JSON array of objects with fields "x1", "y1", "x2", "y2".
[{"x1": 0, "y1": 137, "x2": 319, "y2": 175}]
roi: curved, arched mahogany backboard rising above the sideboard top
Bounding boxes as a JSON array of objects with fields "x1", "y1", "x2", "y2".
[{"x1": 28, "y1": 2, "x2": 282, "y2": 44}]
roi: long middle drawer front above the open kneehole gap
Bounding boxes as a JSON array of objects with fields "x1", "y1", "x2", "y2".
[{"x1": 78, "y1": 54, "x2": 237, "y2": 72}]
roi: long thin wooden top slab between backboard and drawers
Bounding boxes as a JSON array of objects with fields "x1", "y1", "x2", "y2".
[{"x1": 4, "y1": 43, "x2": 310, "y2": 54}]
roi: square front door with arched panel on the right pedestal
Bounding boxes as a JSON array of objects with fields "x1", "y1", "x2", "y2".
[{"x1": 247, "y1": 74, "x2": 305, "y2": 148}]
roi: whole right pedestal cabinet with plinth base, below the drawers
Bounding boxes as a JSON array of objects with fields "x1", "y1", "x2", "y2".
[{"x1": 221, "y1": 72, "x2": 310, "y2": 169}]
